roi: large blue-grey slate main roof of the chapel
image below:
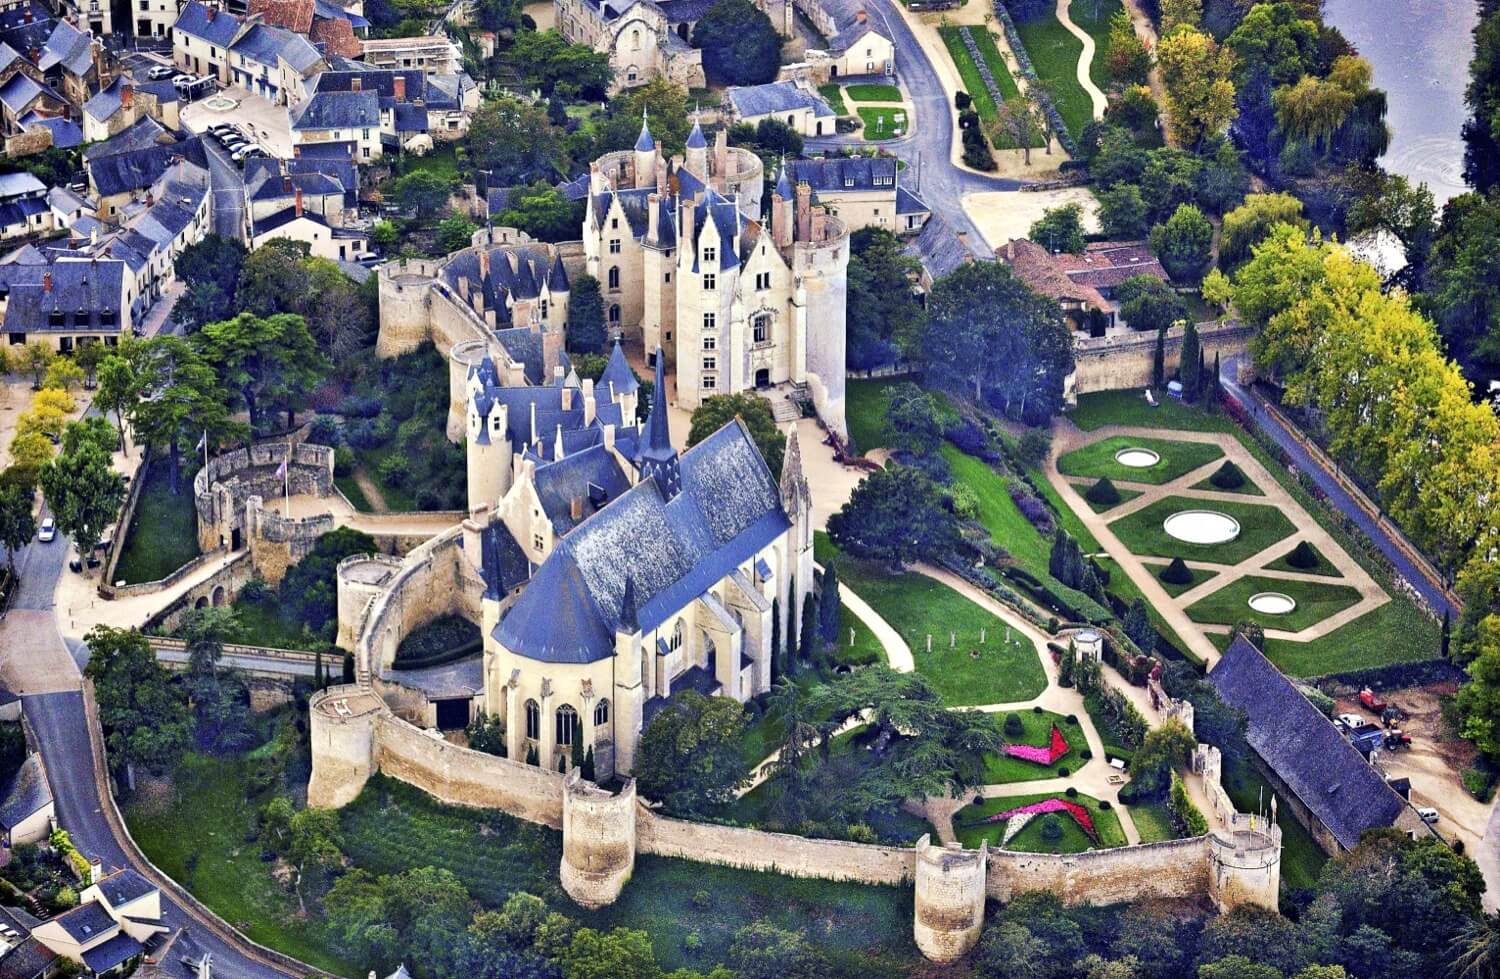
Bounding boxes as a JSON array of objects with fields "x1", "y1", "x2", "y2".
[{"x1": 494, "y1": 418, "x2": 791, "y2": 663}]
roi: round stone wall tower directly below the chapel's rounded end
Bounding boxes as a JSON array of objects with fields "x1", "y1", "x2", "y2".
[{"x1": 560, "y1": 769, "x2": 636, "y2": 909}]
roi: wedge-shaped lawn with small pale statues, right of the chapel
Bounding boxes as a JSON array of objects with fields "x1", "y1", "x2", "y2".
[{"x1": 816, "y1": 534, "x2": 1047, "y2": 706}]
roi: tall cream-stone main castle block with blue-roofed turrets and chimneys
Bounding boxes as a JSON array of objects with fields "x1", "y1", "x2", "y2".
[{"x1": 584, "y1": 114, "x2": 849, "y2": 433}]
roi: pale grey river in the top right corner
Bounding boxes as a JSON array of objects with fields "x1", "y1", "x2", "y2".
[{"x1": 1323, "y1": 0, "x2": 1479, "y2": 207}]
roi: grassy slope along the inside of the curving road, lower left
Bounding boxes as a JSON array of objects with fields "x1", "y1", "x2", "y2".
[{"x1": 125, "y1": 754, "x2": 357, "y2": 976}]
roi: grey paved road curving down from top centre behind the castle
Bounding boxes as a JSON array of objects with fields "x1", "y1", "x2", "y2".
[{"x1": 806, "y1": 0, "x2": 1022, "y2": 258}]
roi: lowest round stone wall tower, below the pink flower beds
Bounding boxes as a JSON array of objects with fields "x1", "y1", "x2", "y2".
[{"x1": 912, "y1": 837, "x2": 990, "y2": 963}]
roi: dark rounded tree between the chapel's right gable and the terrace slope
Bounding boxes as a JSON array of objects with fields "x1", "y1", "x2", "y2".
[{"x1": 828, "y1": 465, "x2": 959, "y2": 567}]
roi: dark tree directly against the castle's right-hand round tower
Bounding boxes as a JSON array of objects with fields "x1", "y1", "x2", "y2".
[{"x1": 846, "y1": 228, "x2": 924, "y2": 370}]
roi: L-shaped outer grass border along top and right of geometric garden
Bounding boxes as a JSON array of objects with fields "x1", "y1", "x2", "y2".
[{"x1": 1073, "y1": 390, "x2": 1439, "y2": 676}]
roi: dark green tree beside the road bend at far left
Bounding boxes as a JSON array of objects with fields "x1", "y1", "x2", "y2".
[{"x1": 84, "y1": 625, "x2": 192, "y2": 775}]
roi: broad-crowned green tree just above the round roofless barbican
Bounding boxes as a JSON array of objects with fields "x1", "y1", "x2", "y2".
[{"x1": 195, "y1": 313, "x2": 327, "y2": 429}]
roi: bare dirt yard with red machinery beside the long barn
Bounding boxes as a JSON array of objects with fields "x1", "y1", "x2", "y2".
[{"x1": 1335, "y1": 684, "x2": 1490, "y2": 852}]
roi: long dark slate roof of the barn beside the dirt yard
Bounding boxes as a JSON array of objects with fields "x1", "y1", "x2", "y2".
[{"x1": 1209, "y1": 636, "x2": 1407, "y2": 849}]
